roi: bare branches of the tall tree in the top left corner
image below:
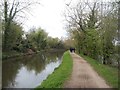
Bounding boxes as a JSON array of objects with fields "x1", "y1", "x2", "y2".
[{"x1": 0, "y1": 0, "x2": 40, "y2": 21}]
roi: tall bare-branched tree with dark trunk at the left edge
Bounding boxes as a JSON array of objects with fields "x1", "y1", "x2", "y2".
[{"x1": 3, "y1": 0, "x2": 39, "y2": 50}]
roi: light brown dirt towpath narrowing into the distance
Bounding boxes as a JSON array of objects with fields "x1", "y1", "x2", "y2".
[{"x1": 64, "y1": 53, "x2": 110, "y2": 88}]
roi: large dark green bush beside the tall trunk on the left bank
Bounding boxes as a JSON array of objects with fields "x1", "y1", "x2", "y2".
[{"x1": 2, "y1": 22, "x2": 23, "y2": 50}]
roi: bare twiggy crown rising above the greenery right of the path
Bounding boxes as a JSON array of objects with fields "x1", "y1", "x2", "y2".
[{"x1": 65, "y1": 1, "x2": 99, "y2": 33}]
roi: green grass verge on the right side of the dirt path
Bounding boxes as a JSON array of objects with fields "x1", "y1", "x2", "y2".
[{"x1": 80, "y1": 54, "x2": 118, "y2": 88}]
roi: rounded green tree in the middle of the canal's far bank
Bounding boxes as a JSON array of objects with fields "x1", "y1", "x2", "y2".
[{"x1": 27, "y1": 28, "x2": 48, "y2": 51}]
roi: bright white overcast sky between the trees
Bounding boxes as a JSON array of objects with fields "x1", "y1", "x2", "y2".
[{"x1": 24, "y1": 0, "x2": 75, "y2": 38}]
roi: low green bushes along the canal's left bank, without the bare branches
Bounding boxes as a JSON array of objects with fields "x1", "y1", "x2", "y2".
[{"x1": 2, "y1": 22, "x2": 64, "y2": 58}]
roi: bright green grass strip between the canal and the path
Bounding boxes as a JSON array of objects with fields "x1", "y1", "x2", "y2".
[{"x1": 36, "y1": 51, "x2": 73, "y2": 89}]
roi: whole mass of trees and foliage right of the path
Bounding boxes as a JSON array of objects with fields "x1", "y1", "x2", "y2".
[{"x1": 65, "y1": 1, "x2": 119, "y2": 65}]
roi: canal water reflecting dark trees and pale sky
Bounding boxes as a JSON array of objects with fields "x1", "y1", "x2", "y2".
[{"x1": 2, "y1": 52, "x2": 63, "y2": 88}]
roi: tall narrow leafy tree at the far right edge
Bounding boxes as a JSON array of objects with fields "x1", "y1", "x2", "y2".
[{"x1": 100, "y1": 2, "x2": 118, "y2": 64}]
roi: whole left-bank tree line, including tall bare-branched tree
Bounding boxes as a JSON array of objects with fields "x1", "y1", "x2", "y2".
[{"x1": 0, "y1": 0, "x2": 64, "y2": 53}]
